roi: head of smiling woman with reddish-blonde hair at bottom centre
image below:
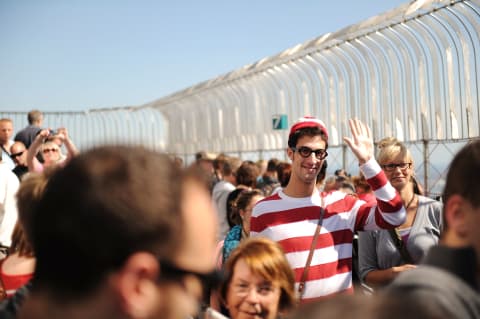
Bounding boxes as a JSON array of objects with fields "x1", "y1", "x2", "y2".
[{"x1": 220, "y1": 238, "x2": 296, "y2": 319}]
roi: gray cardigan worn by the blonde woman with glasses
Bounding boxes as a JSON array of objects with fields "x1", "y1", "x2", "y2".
[{"x1": 358, "y1": 195, "x2": 443, "y2": 281}]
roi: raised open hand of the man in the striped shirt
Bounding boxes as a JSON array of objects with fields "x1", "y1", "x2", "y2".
[{"x1": 343, "y1": 119, "x2": 374, "y2": 164}]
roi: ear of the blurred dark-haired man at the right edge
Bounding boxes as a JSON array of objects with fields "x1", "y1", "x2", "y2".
[{"x1": 444, "y1": 195, "x2": 471, "y2": 240}]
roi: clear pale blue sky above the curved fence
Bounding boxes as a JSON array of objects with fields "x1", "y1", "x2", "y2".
[{"x1": 0, "y1": 0, "x2": 408, "y2": 111}]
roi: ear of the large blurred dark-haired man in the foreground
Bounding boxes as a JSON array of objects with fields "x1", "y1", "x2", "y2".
[{"x1": 111, "y1": 252, "x2": 160, "y2": 318}]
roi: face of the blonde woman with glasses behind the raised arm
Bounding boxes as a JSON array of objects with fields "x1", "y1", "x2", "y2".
[{"x1": 381, "y1": 154, "x2": 414, "y2": 191}]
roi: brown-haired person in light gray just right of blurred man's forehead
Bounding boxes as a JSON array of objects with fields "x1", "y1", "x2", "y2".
[{"x1": 212, "y1": 157, "x2": 242, "y2": 241}]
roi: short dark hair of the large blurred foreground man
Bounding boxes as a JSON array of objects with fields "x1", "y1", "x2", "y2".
[{"x1": 32, "y1": 146, "x2": 185, "y2": 300}]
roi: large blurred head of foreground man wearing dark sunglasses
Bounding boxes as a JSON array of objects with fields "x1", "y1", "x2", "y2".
[{"x1": 18, "y1": 146, "x2": 218, "y2": 319}]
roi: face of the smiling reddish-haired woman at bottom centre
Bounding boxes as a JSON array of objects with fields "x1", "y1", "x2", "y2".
[{"x1": 225, "y1": 259, "x2": 281, "y2": 319}]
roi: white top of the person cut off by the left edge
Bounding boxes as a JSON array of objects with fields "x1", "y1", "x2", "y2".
[{"x1": 0, "y1": 153, "x2": 20, "y2": 248}]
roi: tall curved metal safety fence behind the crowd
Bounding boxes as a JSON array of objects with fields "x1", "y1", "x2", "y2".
[{"x1": 0, "y1": 0, "x2": 480, "y2": 194}]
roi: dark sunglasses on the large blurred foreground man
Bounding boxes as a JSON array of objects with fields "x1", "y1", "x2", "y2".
[{"x1": 158, "y1": 260, "x2": 223, "y2": 288}]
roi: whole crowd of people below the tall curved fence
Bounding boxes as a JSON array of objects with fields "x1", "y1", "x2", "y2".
[{"x1": 0, "y1": 110, "x2": 480, "y2": 319}]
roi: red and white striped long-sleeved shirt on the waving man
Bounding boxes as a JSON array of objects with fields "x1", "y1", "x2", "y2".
[{"x1": 250, "y1": 159, "x2": 406, "y2": 302}]
